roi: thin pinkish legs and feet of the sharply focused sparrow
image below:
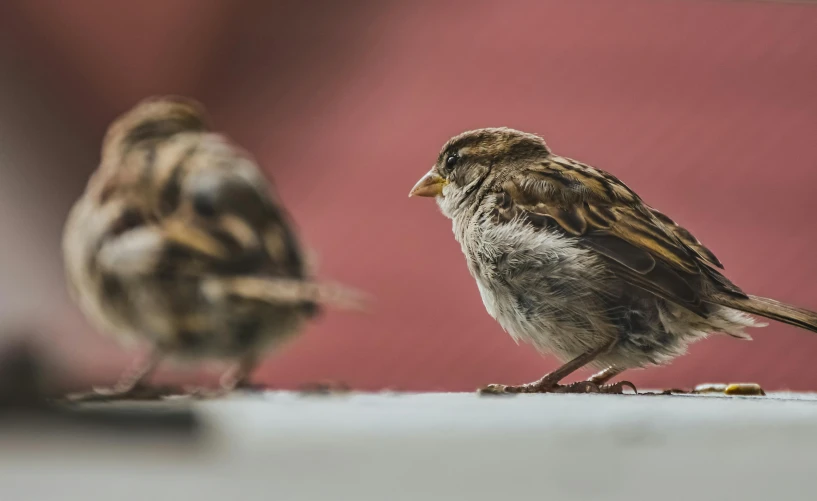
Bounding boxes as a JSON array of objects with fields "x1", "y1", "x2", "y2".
[{"x1": 479, "y1": 340, "x2": 632, "y2": 394}]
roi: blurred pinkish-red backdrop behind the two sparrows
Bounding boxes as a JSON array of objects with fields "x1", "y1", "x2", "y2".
[{"x1": 1, "y1": 0, "x2": 817, "y2": 390}]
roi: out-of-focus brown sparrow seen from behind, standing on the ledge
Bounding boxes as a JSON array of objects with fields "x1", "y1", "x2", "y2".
[{"x1": 63, "y1": 96, "x2": 358, "y2": 396}]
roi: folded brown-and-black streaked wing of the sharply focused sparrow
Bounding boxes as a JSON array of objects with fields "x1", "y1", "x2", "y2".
[{"x1": 494, "y1": 156, "x2": 746, "y2": 315}]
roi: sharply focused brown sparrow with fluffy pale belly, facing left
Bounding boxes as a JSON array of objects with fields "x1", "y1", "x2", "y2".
[{"x1": 409, "y1": 128, "x2": 817, "y2": 393}]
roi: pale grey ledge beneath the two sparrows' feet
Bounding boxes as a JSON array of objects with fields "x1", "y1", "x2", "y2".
[{"x1": 0, "y1": 393, "x2": 817, "y2": 501}]
